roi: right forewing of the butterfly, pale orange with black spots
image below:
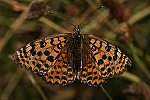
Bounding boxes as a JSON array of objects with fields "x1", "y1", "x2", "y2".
[{"x1": 85, "y1": 34, "x2": 131, "y2": 79}]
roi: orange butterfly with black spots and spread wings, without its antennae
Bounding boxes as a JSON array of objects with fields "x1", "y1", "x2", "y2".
[{"x1": 12, "y1": 26, "x2": 131, "y2": 86}]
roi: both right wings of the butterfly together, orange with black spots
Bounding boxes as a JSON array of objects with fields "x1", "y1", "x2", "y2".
[{"x1": 80, "y1": 34, "x2": 131, "y2": 86}]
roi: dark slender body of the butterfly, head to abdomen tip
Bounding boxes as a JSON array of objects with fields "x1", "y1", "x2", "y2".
[{"x1": 72, "y1": 27, "x2": 82, "y2": 75}]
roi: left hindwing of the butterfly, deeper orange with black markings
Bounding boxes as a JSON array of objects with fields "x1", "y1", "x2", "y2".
[{"x1": 42, "y1": 41, "x2": 75, "y2": 86}]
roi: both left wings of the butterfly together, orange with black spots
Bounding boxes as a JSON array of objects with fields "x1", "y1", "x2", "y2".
[{"x1": 12, "y1": 34, "x2": 74, "y2": 85}]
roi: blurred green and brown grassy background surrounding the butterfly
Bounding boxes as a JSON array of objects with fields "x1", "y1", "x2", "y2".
[{"x1": 0, "y1": 0, "x2": 150, "y2": 100}]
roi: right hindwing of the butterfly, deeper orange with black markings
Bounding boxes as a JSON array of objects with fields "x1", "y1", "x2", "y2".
[{"x1": 80, "y1": 42, "x2": 107, "y2": 86}]
